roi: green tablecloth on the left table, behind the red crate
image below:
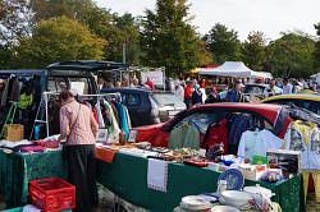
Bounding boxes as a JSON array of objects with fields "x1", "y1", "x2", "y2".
[{"x1": 0, "y1": 151, "x2": 66, "y2": 208}]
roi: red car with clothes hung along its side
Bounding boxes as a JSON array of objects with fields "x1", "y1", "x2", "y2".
[{"x1": 136, "y1": 103, "x2": 318, "y2": 151}]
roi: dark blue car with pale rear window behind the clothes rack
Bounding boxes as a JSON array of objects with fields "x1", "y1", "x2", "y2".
[{"x1": 101, "y1": 88, "x2": 186, "y2": 127}]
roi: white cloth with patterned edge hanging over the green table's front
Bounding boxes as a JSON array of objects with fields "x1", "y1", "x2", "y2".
[{"x1": 147, "y1": 159, "x2": 168, "y2": 192}]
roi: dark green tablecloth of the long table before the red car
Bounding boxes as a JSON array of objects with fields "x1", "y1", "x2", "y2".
[{"x1": 98, "y1": 153, "x2": 304, "y2": 212}]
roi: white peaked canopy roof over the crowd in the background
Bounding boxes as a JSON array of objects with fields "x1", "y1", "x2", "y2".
[{"x1": 199, "y1": 61, "x2": 253, "y2": 77}]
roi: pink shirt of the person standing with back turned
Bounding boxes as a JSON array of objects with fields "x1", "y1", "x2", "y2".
[{"x1": 60, "y1": 100, "x2": 98, "y2": 145}]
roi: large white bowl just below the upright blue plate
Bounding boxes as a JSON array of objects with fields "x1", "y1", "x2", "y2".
[{"x1": 221, "y1": 190, "x2": 252, "y2": 208}]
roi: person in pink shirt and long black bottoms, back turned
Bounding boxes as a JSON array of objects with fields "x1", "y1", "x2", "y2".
[{"x1": 59, "y1": 90, "x2": 98, "y2": 212}]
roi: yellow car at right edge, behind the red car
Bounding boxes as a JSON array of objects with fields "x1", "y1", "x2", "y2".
[{"x1": 261, "y1": 94, "x2": 320, "y2": 116}]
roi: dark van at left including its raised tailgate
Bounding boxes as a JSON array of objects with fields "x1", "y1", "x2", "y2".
[{"x1": 0, "y1": 60, "x2": 125, "y2": 138}]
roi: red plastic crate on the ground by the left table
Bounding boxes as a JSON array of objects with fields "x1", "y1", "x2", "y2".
[{"x1": 29, "y1": 178, "x2": 76, "y2": 212}]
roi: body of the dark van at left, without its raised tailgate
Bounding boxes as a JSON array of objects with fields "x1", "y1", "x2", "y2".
[{"x1": 0, "y1": 69, "x2": 97, "y2": 138}]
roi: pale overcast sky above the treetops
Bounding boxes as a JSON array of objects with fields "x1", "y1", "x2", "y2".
[{"x1": 96, "y1": 0, "x2": 320, "y2": 40}]
